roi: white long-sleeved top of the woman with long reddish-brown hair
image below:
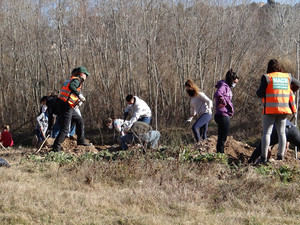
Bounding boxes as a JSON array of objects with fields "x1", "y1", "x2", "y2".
[{"x1": 188, "y1": 92, "x2": 213, "y2": 121}]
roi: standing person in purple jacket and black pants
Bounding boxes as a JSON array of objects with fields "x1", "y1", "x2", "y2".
[{"x1": 214, "y1": 69, "x2": 239, "y2": 153}]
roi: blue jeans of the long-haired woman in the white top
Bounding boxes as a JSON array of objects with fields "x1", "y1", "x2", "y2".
[{"x1": 192, "y1": 113, "x2": 211, "y2": 142}]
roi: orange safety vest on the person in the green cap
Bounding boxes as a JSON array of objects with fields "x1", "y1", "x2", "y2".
[{"x1": 58, "y1": 76, "x2": 81, "y2": 108}]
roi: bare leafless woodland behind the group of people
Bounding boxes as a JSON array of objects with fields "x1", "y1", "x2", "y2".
[{"x1": 0, "y1": 0, "x2": 300, "y2": 140}]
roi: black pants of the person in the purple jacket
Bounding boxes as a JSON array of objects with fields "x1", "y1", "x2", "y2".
[{"x1": 215, "y1": 114, "x2": 230, "y2": 153}]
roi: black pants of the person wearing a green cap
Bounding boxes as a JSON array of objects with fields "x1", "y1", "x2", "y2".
[{"x1": 53, "y1": 100, "x2": 84, "y2": 150}]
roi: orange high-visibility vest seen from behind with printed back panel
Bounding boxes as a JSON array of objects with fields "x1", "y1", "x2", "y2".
[{"x1": 262, "y1": 72, "x2": 292, "y2": 114}]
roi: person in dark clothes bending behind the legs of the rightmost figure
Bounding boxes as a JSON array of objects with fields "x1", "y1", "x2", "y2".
[{"x1": 248, "y1": 119, "x2": 300, "y2": 163}]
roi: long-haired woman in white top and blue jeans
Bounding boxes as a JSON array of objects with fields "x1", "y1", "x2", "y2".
[{"x1": 185, "y1": 80, "x2": 213, "y2": 144}]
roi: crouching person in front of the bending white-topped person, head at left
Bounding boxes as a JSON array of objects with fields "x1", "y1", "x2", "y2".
[{"x1": 105, "y1": 118, "x2": 160, "y2": 150}]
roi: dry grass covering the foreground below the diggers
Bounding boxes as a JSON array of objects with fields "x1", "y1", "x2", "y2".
[{"x1": 0, "y1": 149, "x2": 300, "y2": 225}]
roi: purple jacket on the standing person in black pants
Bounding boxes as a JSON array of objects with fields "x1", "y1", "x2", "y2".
[{"x1": 214, "y1": 80, "x2": 234, "y2": 117}]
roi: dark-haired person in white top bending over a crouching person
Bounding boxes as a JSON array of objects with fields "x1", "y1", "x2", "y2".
[{"x1": 124, "y1": 95, "x2": 152, "y2": 130}]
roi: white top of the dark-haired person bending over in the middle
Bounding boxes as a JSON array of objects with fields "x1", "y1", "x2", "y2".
[{"x1": 125, "y1": 96, "x2": 152, "y2": 130}]
